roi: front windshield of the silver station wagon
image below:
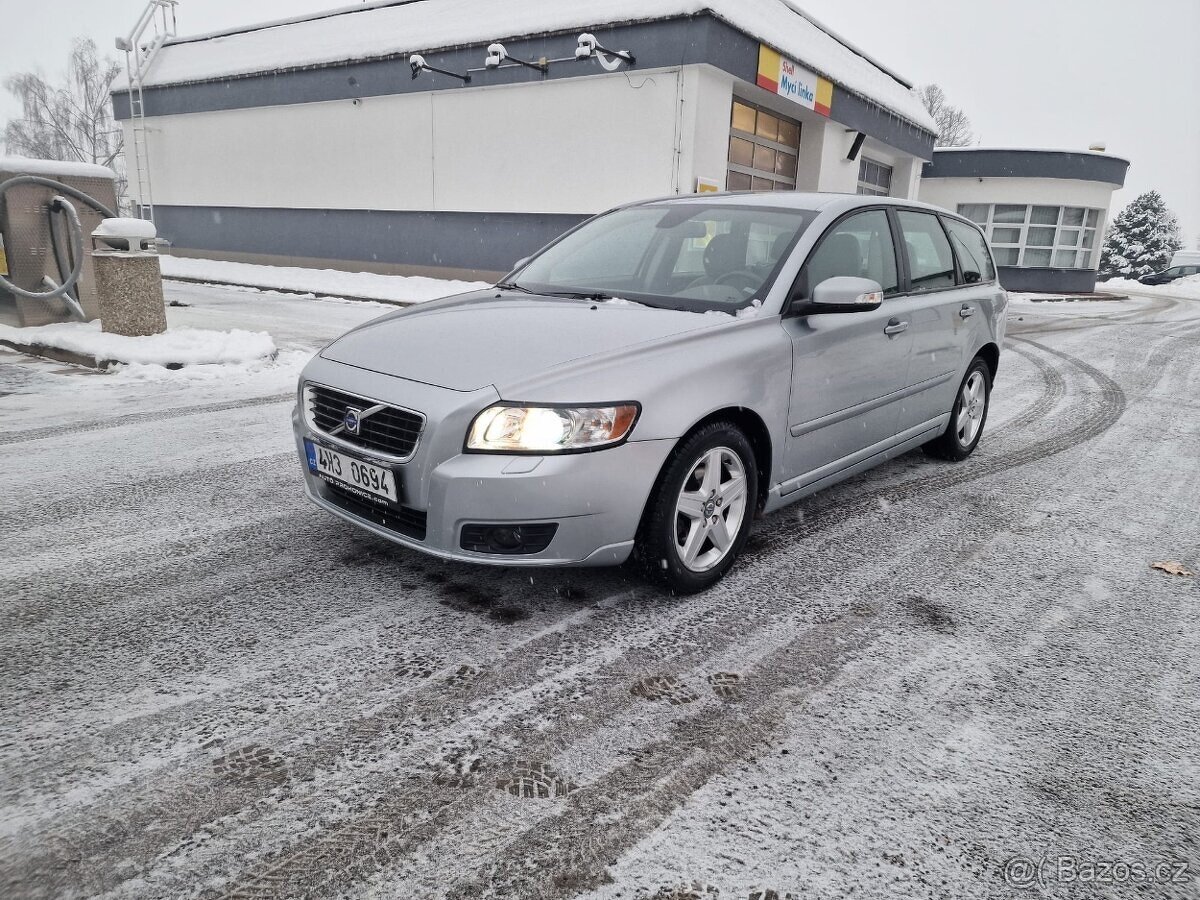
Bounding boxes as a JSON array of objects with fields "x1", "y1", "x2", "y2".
[{"x1": 509, "y1": 203, "x2": 816, "y2": 312}]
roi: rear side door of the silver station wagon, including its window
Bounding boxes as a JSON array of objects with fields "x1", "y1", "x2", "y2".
[{"x1": 884, "y1": 209, "x2": 983, "y2": 432}]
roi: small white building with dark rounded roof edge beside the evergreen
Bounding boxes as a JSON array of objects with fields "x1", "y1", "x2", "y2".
[{"x1": 920, "y1": 148, "x2": 1129, "y2": 293}]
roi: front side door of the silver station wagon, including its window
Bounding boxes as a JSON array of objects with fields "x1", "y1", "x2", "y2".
[{"x1": 784, "y1": 208, "x2": 912, "y2": 493}]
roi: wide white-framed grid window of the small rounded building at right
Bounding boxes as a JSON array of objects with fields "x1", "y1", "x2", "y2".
[{"x1": 959, "y1": 203, "x2": 1100, "y2": 269}]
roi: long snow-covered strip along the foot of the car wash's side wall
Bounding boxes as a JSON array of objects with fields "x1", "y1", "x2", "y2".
[{"x1": 161, "y1": 257, "x2": 491, "y2": 304}]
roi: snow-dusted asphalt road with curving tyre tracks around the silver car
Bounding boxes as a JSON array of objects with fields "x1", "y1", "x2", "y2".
[{"x1": 0, "y1": 286, "x2": 1200, "y2": 900}]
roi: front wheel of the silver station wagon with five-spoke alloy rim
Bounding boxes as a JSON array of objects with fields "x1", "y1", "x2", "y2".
[{"x1": 634, "y1": 421, "x2": 758, "y2": 594}]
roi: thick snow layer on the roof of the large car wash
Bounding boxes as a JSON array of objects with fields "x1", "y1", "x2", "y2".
[{"x1": 131, "y1": 0, "x2": 936, "y2": 132}]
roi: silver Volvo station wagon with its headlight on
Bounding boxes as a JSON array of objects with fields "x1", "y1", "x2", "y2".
[{"x1": 293, "y1": 193, "x2": 1007, "y2": 593}]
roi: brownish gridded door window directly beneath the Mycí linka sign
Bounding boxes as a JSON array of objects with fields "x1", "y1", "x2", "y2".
[{"x1": 726, "y1": 100, "x2": 800, "y2": 191}]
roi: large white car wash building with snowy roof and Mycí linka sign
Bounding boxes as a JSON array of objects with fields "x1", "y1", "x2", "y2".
[{"x1": 114, "y1": 0, "x2": 936, "y2": 276}]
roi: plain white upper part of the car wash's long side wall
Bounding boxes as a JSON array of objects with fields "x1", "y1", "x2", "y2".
[{"x1": 126, "y1": 70, "x2": 686, "y2": 214}]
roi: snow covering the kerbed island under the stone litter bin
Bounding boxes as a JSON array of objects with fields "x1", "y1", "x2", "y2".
[{"x1": 0, "y1": 322, "x2": 276, "y2": 367}]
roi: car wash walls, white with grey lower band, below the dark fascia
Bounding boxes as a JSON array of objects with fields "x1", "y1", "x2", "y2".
[{"x1": 124, "y1": 56, "x2": 936, "y2": 277}]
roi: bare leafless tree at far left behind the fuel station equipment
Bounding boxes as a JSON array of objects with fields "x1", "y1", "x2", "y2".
[{"x1": 4, "y1": 38, "x2": 125, "y2": 193}]
